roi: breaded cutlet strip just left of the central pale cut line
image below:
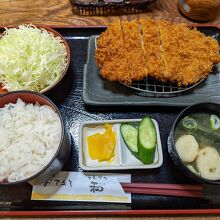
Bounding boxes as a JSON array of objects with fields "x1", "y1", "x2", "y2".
[{"x1": 121, "y1": 20, "x2": 148, "y2": 81}]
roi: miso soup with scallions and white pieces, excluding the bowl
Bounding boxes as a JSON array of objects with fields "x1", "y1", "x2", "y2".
[{"x1": 174, "y1": 113, "x2": 220, "y2": 180}]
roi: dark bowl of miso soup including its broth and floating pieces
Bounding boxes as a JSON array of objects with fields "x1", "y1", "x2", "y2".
[{"x1": 168, "y1": 103, "x2": 220, "y2": 184}]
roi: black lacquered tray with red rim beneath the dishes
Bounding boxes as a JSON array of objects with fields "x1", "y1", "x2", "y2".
[{"x1": 0, "y1": 28, "x2": 220, "y2": 215}]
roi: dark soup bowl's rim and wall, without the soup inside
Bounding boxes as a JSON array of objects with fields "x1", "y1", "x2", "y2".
[{"x1": 167, "y1": 103, "x2": 220, "y2": 184}]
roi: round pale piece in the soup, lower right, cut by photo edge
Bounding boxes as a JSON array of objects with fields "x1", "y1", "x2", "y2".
[{"x1": 196, "y1": 146, "x2": 220, "y2": 180}]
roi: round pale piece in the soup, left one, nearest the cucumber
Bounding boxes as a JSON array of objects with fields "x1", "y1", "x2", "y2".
[{"x1": 175, "y1": 135, "x2": 199, "y2": 162}]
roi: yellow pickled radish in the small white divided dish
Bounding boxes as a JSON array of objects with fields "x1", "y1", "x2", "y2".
[{"x1": 87, "y1": 124, "x2": 116, "y2": 162}]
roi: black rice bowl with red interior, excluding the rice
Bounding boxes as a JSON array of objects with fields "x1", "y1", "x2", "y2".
[{"x1": 0, "y1": 91, "x2": 70, "y2": 185}]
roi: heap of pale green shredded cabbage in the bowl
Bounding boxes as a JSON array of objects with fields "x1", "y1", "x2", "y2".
[{"x1": 0, "y1": 25, "x2": 67, "y2": 92}]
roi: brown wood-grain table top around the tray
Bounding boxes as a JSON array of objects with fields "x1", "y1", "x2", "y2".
[{"x1": 0, "y1": 0, "x2": 220, "y2": 220}]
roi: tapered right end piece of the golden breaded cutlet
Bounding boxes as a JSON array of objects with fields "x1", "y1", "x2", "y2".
[{"x1": 173, "y1": 24, "x2": 219, "y2": 85}]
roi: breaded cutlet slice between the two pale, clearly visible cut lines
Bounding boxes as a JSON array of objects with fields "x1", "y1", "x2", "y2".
[{"x1": 139, "y1": 18, "x2": 165, "y2": 81}]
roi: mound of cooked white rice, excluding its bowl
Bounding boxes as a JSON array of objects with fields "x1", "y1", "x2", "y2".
[{"x1": 0, "y1": 99, "x2": 61, "y2": 182}]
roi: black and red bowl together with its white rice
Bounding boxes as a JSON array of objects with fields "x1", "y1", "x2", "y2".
[{"x1": 0, "y1": 91, "x2": 70, "y2": 185}]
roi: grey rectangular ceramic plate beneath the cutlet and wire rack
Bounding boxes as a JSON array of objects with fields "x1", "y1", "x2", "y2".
[{"x1": 83, "y1": 26, "x2": 220, "y2": 107}]
